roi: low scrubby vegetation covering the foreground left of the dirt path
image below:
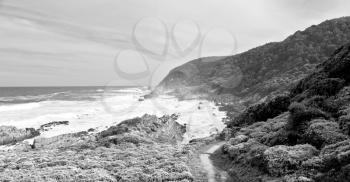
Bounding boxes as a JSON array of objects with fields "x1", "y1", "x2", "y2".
[{"x1": 0, "y1": 115, "x2": 194, "y2": 182}]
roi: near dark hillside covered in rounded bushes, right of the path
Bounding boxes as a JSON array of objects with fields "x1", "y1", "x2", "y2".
[{"x1": 218, "y1": 44, "x2": 350, "y2": 182}]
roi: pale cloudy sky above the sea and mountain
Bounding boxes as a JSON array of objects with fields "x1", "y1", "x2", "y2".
[{"x1": 0, "y1": 0, "x2": 350, "y2": 87}]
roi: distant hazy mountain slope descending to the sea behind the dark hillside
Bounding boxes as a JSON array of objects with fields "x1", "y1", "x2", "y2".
[{"x1": 157, "y1": 17, "x2": 350, "y2": 102}]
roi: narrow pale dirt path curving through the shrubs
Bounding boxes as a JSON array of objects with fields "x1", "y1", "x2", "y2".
[{"x1": 199, "y1": 142, "x2": 229, "y2": 182}]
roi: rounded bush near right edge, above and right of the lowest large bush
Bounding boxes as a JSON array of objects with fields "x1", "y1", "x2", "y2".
[{"x1": 304, "y1": 119, "x2": 349, "y2": 148}]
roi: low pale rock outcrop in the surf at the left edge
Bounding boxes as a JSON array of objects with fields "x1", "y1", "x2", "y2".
[{"x1": 0, "y1": 126, "x2": 40, "y2": 145}]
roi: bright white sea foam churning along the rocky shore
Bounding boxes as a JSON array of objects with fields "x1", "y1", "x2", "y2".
[{"x1": 0, "y1": 89, "x2": 225, "y2": 141}]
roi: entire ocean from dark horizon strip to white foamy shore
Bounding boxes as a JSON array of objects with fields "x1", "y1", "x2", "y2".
[{"x1": 0, "y1": 87, "x2": 225, "y2": 141}]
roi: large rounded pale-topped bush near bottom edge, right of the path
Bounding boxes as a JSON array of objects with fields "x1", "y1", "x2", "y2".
[{"x1": 263, "y1": 144, "x2": 318, "y2": 176}]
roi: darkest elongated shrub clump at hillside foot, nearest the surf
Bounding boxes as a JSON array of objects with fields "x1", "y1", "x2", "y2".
[{"x1": 227, "y1": 95, "x2": 290, "y2": 127}]
